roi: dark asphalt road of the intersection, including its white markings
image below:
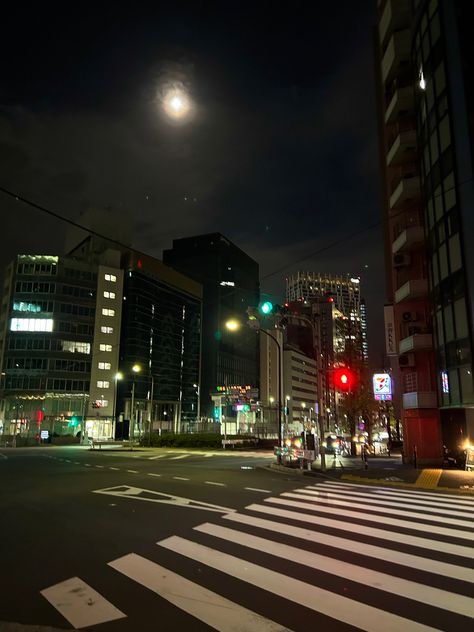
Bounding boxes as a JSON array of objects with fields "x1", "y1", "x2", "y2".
[{"x1": 0, "y1": 447, "x2": 474, "y2": 632}]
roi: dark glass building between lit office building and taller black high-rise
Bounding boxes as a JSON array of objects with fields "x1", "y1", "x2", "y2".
[{"x1": 118, "y1": 254, "x2": 202, "y2": 435}]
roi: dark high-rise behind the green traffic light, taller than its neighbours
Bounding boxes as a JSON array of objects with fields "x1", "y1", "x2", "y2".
[{"x1": 163, "y1": 233, "x2": 259, "y2": 417}]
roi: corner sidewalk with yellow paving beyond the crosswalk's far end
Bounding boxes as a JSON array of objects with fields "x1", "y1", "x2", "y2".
[{"x1": 270, "y1": 455, "x2": 474, "y2": 495}]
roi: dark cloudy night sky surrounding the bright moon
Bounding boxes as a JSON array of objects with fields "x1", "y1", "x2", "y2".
[{"x1": 0, "y1": 0, "x2": 385, "y2": 363}]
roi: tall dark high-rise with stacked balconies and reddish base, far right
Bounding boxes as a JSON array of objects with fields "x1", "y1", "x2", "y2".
[{"x1": 375, "y1": 0, "x2": 474, "y2": 461}]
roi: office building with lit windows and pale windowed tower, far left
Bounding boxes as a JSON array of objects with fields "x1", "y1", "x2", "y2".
[{"x1": 0, "y1": 255, "x2": 121, "y2": 437}]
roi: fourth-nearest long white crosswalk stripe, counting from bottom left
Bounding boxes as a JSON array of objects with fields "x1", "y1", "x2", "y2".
[{"x1": 223, "y1": 513, "x2": 474, "y2": 583}]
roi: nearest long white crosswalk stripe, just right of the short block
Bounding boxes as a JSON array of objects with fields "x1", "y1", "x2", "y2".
[{"x1": 109, "y1": 553, "x2": 289, "y2": 632}]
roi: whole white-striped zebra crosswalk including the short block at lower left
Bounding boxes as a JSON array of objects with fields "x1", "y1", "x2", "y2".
[{"x1": 41, "y1": 480, "x2": 474, "y2": 632}]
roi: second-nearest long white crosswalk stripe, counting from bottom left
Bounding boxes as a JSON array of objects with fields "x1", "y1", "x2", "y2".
[{"x1": 158, "y1": 536, "x2": 435, "y2": 632}]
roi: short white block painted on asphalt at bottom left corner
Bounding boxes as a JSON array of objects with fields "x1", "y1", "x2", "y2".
[{"x1": 40, "y1": 577, "x2": 127, "y2": 628}]
